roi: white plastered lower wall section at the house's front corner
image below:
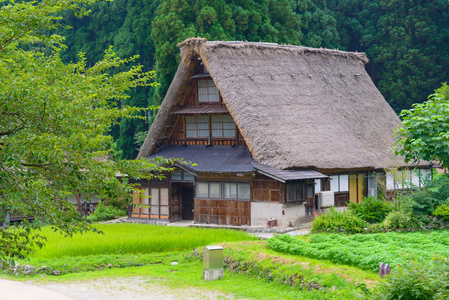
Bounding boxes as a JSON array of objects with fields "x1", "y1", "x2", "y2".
[{"x1": 251, "y1": 202, "x2": 306, "y2": 228}]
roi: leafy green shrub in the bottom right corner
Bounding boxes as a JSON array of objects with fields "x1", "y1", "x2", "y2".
[{"x1": 368, "y1": 258, "x2": 449, "y2": 300}]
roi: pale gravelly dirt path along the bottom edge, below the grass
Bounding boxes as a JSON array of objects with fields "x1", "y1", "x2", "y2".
[{"x1": 29, "y1": 277, "x2": 238, "y2": 300}]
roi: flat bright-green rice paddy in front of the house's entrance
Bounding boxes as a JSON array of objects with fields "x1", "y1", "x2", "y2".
[{"x1": 31, "y1": 224, "x2": 257, "y2": 258}]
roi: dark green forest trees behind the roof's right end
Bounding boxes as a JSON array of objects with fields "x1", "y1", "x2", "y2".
[{"x1": 327, "y1": 0, "x2": 449, "y2": 112}]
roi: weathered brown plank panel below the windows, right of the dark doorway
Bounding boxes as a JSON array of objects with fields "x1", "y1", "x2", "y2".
[{"x1": 194, "y1": 198, "x2": 251, "y2": 226}]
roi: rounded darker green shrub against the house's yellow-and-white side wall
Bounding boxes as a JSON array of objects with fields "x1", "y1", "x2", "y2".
[{"x1": 349, "y1": 196, "x2": 393, "y2": 224}]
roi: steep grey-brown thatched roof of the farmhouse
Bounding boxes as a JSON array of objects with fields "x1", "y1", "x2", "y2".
[{"x1": 138, "y1": 38, "x2": 414, "y2": 170}]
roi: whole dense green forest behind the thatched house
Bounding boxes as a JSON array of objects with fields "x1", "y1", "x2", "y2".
[{"x1": 56, "y1": 0, "x2": 449, "y2": 159}]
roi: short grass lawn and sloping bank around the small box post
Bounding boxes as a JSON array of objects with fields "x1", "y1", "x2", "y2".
[{"x1": 9, "y1": 241, "x2": 377, "y2": 299}]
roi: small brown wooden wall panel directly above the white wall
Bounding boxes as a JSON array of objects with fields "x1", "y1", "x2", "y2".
[{"x1": 252, "y1": 174, "x2": 285, "y2": 202}]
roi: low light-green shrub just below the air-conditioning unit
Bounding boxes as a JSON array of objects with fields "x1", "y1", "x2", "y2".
[{"x1": 312, "y1": 206, "x2": 368, "y2": 233}]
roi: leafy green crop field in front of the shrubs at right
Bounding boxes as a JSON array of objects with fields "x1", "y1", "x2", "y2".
[{"x1": 268, "y1": 231, "x2": 449, "y2": 271}]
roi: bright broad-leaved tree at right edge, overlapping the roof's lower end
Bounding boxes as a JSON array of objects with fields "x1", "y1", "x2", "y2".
[{"x1": 395, "y1": 83, "x2": 449, "y2": 168}]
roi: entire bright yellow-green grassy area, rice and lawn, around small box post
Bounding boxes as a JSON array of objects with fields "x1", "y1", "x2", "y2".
[{"x1": 3, "y1": 224, "x2": 378, "y2": 299}]
